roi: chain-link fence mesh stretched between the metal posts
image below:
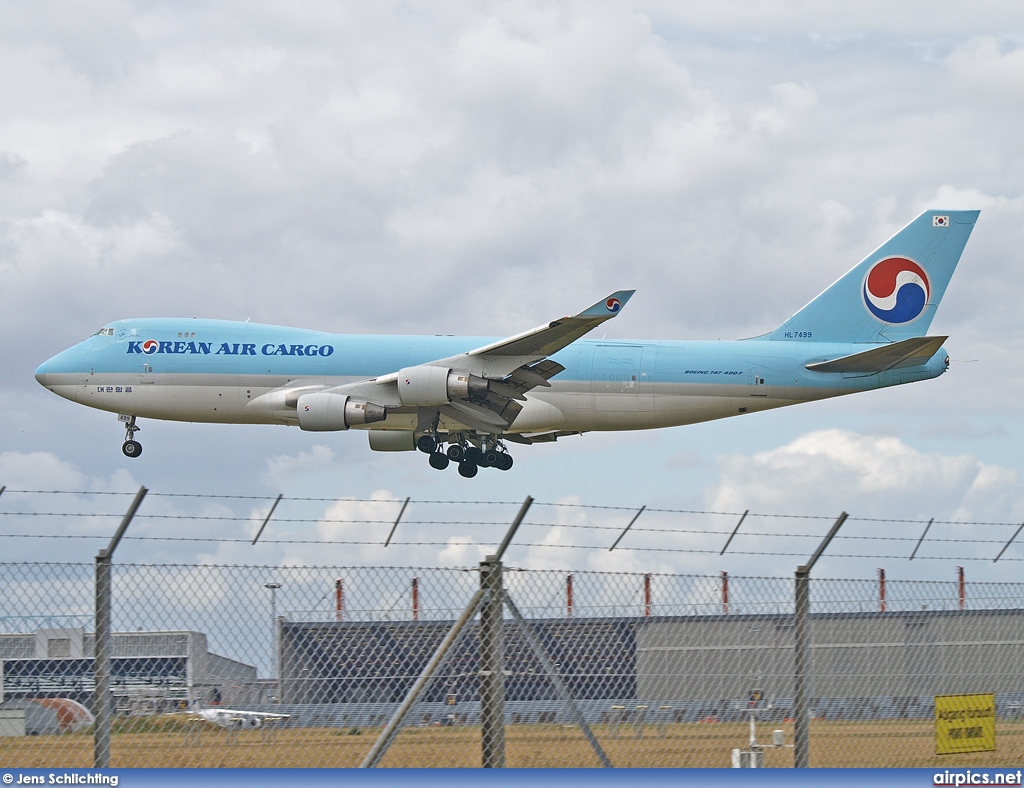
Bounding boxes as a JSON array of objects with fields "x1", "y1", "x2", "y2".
[{"x1": 0, "y1": 563, "x2": 1024, "y2": 767}]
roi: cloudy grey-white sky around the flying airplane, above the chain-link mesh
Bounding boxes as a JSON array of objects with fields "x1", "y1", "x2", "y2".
[{"x1": 0, "y1": 0, "x2": 1024, "y2": 580}]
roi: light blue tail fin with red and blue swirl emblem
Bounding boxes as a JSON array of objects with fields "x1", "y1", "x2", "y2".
[{"x1": 769, "y1": 211, "x2": 980, "y2": 342}]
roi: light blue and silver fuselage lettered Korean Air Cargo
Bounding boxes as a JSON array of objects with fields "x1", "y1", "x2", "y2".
[{"x1": 36, "y1": 318, "x2": 948, "y2": 433}]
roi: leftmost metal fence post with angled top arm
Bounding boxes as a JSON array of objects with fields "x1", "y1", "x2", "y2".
[{"x1": 92, "y1": 487, "x2": 147, "y2": 769}]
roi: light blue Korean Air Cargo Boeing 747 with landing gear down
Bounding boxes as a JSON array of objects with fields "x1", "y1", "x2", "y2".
[{"x1": 36, "y1": 211, "x2": 979, "y2": 477}]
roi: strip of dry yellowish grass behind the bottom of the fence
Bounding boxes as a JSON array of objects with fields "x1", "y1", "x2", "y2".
[{"x1": 6, "y1": 718, "x2": 1024, "y2": 768}]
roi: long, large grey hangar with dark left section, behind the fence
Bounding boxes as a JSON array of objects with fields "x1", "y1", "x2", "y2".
[{"x1": 279, "y1": 610, "x2": 1024, "y2": 725}]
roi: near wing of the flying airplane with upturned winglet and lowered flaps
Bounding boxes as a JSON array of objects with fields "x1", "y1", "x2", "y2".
[{"x1": 330, "y1": 290, "x2": 635, "y2": 432}]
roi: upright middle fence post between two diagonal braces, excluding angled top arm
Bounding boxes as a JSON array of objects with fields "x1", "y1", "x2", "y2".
[{"x1": 480, "y1": 556, "x2": 505, "y2": 769}]
